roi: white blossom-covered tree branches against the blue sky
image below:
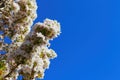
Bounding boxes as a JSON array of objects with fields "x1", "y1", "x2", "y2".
[{"x1": 0, "y1": 0, "x2": 60, "y2": 80}]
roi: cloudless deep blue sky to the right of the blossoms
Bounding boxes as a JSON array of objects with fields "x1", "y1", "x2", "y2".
[{"x1": 36, "y1": 0, "x2": 120, "y2": 80}]
